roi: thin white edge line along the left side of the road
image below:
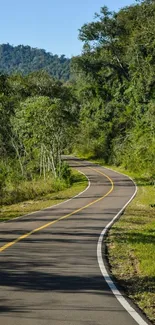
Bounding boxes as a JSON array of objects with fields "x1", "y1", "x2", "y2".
[{"x1": 3, "y1": 167, "x2": 91, "y2": 223}]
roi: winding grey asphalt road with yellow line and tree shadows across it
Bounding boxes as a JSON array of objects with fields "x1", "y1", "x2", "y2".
[{"x1": 0, "y1": 159, "x2": 149, "y2": 325}]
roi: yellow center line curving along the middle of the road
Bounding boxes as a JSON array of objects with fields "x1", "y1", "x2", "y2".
[{"x1": 0, "y1": 167, "x2": 114, "y2": 252}]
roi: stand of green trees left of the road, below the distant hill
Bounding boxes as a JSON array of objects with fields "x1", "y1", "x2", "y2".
[{"x1": 0, "y1": 72, "x2": 78, "y2": 204}]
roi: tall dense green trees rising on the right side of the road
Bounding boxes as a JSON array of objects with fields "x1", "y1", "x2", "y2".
[{"x1": 73, "y1": 0, "x2": 155, "y2": 179}]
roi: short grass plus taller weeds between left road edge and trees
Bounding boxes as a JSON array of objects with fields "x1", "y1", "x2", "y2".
[{"x1": 0, "y1": 170, "x2": 88, "y2": 221}]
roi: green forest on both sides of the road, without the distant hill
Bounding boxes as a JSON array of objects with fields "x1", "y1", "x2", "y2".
[{"x1": 0, "y1": 0, "x2": 155, "y2": 204}]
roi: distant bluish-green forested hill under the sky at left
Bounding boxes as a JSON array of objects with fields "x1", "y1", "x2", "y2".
[{"x1": 0, "y1": 44, "x2": 70, "y2": 81}]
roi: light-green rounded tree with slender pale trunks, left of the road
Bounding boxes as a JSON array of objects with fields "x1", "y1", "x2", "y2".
[{"x1": 12, "y1": 88, "x2": 78, "y2": 178}]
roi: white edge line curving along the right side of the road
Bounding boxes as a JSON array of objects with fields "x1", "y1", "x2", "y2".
[{"x1": 97, "y1": 166, "x2": 148, "y2": 325}]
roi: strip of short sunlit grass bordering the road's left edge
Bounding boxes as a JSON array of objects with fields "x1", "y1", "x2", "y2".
[{"x1": 0, "y1": 170, "x2": 88, "y2": 222}]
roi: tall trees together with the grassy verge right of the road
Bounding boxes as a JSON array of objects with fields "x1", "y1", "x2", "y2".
[{"x1": 72, "y1": 0, "x2": 155, "y2": 322}]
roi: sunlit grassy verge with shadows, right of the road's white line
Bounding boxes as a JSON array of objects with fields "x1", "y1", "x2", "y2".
[{"x1": 78, "y1": 159, "x2": 155, "y2": 324}]
